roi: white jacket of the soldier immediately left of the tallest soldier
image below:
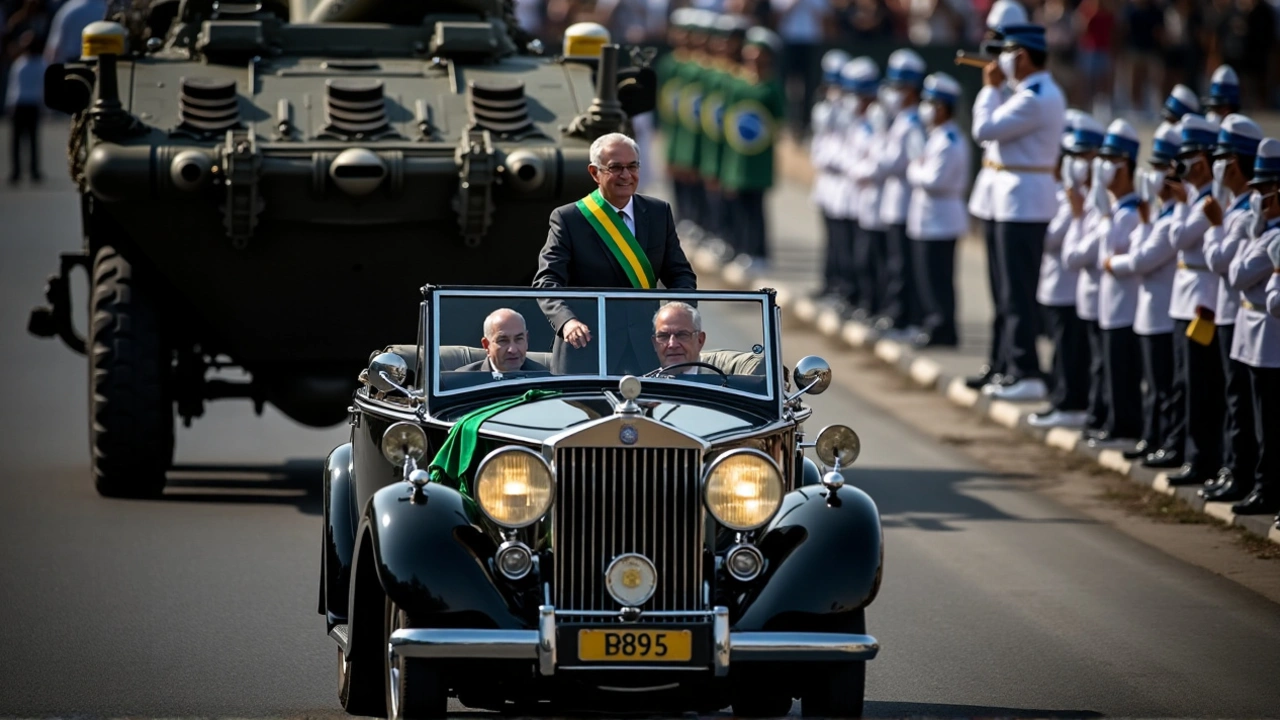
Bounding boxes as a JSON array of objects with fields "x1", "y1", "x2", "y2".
[{"x1": 906, "y1": 120, "x2": 969, "y2": 240}]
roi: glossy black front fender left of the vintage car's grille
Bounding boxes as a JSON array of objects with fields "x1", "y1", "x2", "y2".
[{"x1": 361, "y1": 483, "x2": 525, "y2": 629}]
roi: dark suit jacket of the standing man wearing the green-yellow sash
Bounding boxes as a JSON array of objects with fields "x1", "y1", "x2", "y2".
[{"x1": 534, "y1": 195, "x2": 698, "y2": 373}]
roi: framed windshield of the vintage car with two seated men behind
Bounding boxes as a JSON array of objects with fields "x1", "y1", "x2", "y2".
[{"x1": 426, "y1": 290, "x2": 778, "y2": 398}]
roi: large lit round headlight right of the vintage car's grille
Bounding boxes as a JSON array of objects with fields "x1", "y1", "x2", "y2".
[{"x1": 704, "y1": 448, "x2": 782, "y2": 530}]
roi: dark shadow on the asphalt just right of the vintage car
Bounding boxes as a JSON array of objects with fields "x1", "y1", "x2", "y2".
[{"x1": 845, "y1": 465, "x2": 1094, "y2": 532}]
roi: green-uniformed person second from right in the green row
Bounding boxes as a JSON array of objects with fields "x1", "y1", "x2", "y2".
[{"x1": 698, "y1": 15, "x2": 750, "y2": 245}]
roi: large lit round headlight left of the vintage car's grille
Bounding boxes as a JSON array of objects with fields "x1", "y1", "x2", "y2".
[{"x1": 476, "y1": 447, "x2": 554, "y2": 528}]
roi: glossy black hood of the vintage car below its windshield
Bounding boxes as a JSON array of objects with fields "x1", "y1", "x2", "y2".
[{"x1": 448, "y1": 396, "x2": 771, "y2": 442}]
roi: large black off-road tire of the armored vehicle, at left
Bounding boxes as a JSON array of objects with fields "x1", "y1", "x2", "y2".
[{"x1": 88, "y1": 246, "x2": 174, "y2": 497}]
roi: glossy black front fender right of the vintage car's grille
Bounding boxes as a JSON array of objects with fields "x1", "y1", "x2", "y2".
[{"x1": 733, "y1": 486, "x2": 884, "y2": 630}]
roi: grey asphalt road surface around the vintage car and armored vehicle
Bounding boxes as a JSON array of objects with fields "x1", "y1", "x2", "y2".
[{"x1": 0, "y1": 120, "x2": 1280, "y2": 717}]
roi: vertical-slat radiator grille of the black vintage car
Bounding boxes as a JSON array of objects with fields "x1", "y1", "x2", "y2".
[{"x1": 553, "y1": 447, "x2": 707, "y2": 621}]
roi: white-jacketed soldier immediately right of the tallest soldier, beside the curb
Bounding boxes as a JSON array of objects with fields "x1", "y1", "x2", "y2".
[{"x1": 1027, "y1": 109, "x2": 1105, "y2": 428}]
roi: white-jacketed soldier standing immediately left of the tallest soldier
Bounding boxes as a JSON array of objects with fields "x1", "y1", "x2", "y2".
[{"x1": 906, "y1": 73, "x2": 970, "y2": 347}]
